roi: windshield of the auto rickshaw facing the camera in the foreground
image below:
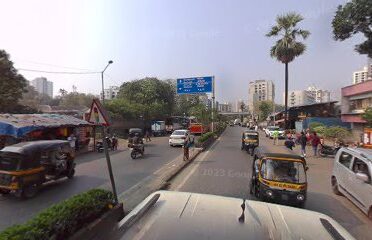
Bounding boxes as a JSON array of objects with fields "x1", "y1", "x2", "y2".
[{"x1": 261, "y1": 159, "x2": 306, "y2": 183}]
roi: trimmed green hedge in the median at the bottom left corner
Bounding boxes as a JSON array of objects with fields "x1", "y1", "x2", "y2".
[{"x1": 0, "y1": 189, "x2": 114, "y2": 240}]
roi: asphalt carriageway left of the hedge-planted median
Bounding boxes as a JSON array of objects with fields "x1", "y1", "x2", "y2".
[{"x1": 0, "y1": 137, "x2": 182, "y2": 230}]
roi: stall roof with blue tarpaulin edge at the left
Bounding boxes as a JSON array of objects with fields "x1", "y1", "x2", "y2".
[{"x1": 0, "y1": 114, "x2": 91, "y2": 138}]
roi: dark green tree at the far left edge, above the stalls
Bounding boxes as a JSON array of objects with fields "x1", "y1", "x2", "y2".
[{"x1": 0, "y1": 50, "x2": 27, "y2": 112}]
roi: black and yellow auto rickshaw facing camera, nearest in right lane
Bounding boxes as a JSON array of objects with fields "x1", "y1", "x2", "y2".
[{"x1": 250, "y1": 149, "x2": 308, "y2": 207}]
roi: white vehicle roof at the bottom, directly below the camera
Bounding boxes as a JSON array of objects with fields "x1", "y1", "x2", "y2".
[{"x1": 115, "y1": 191, "x2": 354, "y2": 240}]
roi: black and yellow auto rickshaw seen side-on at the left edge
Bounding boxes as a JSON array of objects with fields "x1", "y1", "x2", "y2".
[{"x1": 0, "y1": 140, "x2": 75, "y2": 198}]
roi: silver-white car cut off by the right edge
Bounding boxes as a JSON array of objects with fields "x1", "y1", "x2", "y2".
[{"x1": 331, "y1": 148, "x2": 372, "y2": 220}]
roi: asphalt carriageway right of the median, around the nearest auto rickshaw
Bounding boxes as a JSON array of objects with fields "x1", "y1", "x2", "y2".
[{"x1": 170, "y1": 127, "x2": 372, "y2": 240}]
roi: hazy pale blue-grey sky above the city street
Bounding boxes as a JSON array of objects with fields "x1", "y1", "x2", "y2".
[{"x1": 0, "y1": 0, "x2": 367, "y2": 103}]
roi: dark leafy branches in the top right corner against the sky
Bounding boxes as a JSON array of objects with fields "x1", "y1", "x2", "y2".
[{"x1": 332, "y1": 0, "x2": 372, "y2": 58}]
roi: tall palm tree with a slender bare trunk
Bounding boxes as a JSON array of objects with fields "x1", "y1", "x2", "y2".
[{"x1": 266, "y1": 13, "x2": 310, "y2": 128}]
